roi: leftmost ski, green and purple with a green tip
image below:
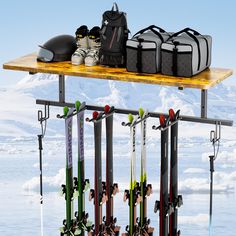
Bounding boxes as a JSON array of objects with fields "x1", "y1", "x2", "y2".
[{"x1": 60, "y1": 107, "x2": 78, "y2": 236}]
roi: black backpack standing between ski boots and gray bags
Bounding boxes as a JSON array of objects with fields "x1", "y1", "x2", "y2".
[{"x1": 99, "y1": 3, "x2": 129, "y2": 67}]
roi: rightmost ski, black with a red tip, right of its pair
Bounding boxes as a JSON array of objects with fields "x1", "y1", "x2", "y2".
[{"x1": 169, "y1": 109, "x2": 183, "y2": 236}]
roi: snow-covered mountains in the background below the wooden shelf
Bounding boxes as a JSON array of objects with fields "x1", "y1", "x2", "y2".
[{"x1": 0, "y1": 74, "x2": 236, "y2": 137}]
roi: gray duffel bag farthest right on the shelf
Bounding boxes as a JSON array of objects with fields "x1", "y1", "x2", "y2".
[{"x1": 161, "y1": 28, "x2": 212, "y2": 77}]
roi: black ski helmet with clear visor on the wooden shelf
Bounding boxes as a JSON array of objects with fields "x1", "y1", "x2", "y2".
[{"x1": 37, "y1": 35, "x2": 77, "y2": 62}]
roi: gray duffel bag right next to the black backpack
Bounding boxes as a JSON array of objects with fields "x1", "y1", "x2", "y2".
[{"x1": 126, "y1": 25, "x2": 170, "y2": 74}]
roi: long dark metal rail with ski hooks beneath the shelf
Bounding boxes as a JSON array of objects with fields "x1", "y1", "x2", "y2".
[{"x1": 36, "y1": 99, "x2": 233, "y2": 127}]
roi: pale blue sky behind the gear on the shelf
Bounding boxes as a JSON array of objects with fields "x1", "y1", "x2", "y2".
[{"x1": 0, "y1": 0, "x2": 236, "y2": 88}]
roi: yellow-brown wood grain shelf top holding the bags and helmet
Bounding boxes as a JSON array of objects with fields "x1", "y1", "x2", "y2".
[{"x1": 3, "y1": 53, "x2": 233, "y2": 89}]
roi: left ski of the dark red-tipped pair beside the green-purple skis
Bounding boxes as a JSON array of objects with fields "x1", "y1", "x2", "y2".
[{"x1": 86, "y1": 111, "x2": 107, "y2": 236}]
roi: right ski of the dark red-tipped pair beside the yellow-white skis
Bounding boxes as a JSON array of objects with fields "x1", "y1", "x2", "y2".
[{"x1": 103, "y1": 105, "x2": 120, "y2": 235}]
